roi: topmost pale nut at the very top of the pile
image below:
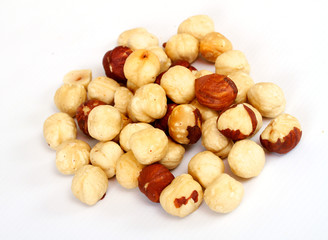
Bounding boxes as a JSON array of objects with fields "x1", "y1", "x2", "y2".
[{"x1": 178, "y1": 15, "x2": 214, "y2": 40}]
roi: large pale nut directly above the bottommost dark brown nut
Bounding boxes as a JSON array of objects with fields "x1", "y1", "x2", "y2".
[{"x1": 130, "y1": 128, "x2": 168, "y2": 165}]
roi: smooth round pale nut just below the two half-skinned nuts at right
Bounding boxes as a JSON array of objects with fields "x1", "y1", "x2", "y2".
[{"x1": 228, "y1": 139, "x2": 265, "y2": 178}]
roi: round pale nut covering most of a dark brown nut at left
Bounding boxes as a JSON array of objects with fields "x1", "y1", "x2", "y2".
[{"x1": 88, "y1": 105, "x2": 123, "y2": 141}]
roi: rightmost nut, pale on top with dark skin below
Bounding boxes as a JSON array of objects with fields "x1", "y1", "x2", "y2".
[{"x1": 260, "y1": 113, "x2": 302, "y2": 154}]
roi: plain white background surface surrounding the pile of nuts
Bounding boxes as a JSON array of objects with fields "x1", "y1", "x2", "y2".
[{"x1": 0, "y1": 0, "x2": 328, "y2": 239}]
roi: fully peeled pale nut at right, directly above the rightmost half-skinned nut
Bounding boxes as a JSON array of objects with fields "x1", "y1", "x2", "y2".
[{"x1": 247, "y1": 82, "x2": 286, "y2": 118}]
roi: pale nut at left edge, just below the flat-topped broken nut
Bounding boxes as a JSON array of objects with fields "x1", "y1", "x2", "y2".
[{"x1": 54, "y1": 83, "x2": 87, "y2": 117}]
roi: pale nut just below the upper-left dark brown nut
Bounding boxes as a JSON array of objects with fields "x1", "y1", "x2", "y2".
[{"x1": 88, "y1": 77, "x2": 120, "y2": 104}]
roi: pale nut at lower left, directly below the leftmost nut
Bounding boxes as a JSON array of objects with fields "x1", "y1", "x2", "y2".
[{"x1": 56, "y1": 139, "x2": 91, "y2": 174}]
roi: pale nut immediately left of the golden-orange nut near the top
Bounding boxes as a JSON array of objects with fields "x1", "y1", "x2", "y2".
[{"x1": 165, "y1": 33, "x2": 199, "y2": 63}]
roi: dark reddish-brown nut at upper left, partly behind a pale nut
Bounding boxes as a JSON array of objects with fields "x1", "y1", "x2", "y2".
[{"x1": 103, "y1": 46, "x2": 132, "y2": 83}]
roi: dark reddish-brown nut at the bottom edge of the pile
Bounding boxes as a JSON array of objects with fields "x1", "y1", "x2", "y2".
[{"x1": 138, "y1": 163, "x2": 174, "y2": 202}]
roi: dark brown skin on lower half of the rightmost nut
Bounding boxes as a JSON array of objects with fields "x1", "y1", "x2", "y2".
[{"x1": 260, "y1": 127, "x2": 302, "y2": 154}]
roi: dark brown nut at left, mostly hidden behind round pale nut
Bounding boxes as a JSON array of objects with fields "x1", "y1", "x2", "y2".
[{"x1": 76, "y1": 99, "x2": 106, "y2": 136}]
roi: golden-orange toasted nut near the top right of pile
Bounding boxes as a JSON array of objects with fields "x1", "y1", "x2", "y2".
[{"x1": 199, "y1": 32, "x2": 232, "y2": 63}]
